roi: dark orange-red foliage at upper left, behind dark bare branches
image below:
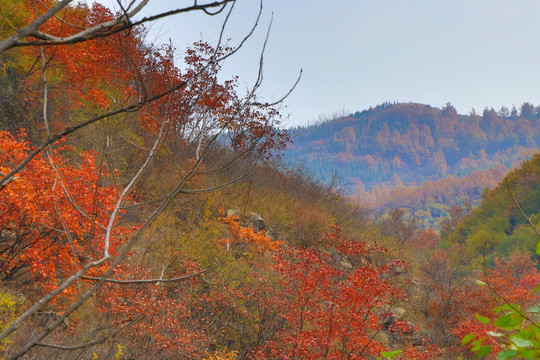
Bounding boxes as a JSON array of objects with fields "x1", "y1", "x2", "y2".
[{"x1": 16, "y1": 2, "x2": 142, "y2": 116}]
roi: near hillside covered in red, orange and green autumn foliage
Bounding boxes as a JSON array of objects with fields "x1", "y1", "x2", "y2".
[{"x1": 0, "y1": 0, "x2": 540, "y2": 360}]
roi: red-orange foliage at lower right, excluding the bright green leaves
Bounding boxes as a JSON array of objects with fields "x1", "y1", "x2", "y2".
[{"x1": 426, "y1": 250, "x2": 540, "y2": 358}]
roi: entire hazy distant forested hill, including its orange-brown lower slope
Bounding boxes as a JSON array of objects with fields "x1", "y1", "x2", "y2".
[{"x1": 286, "y1": 103, "x2": 540, "y2": 227}]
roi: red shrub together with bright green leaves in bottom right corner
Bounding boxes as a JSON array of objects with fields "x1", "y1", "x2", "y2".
[{"x1": 452, "y1": 252, "x2": 540, "y2": 359}]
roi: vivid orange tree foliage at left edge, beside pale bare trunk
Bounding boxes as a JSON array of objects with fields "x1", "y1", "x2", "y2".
[{"x1": 0, "y1": 132, "x2": 124, "y2": 300}]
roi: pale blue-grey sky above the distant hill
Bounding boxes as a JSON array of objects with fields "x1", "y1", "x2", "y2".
[{"x1": 103, "y1": 0, "x2": 540, "y2": 127}]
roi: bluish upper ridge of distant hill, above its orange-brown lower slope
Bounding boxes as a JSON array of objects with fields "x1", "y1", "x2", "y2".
[{"x1": 285, "y1": 103, "x2": 540, "y2": 192}]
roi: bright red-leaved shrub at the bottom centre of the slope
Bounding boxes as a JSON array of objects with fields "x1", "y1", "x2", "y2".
[{"x1": 256, "y1": 228, "x2": 418, "y2": 359}]
